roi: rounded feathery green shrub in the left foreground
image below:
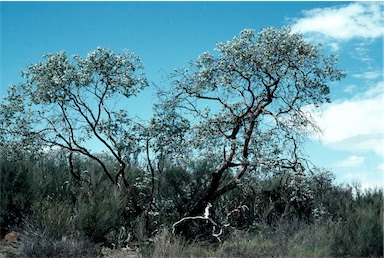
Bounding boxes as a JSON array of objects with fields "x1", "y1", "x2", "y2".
[{"x1": 21, "y1": 196, "x2": 99, "y2": 257}]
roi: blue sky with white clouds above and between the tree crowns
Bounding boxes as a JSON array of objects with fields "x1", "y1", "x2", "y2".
[{"x1": 0, "y1": 2, "x2": 384, "y2": 187}]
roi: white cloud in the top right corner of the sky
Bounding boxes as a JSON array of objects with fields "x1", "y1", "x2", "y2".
[{"x1": 292, "y1": 2, "x2": 384, "y2": 40}]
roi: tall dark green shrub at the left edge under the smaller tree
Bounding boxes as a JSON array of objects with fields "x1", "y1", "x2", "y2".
[{"x1": 0, "y1": 145, "x2": 77, "y2": 236}]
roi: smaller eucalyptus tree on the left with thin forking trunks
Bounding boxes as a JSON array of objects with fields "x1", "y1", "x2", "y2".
[{"x1": 0, "y1": 48, "x2": 148, "y2": 214}]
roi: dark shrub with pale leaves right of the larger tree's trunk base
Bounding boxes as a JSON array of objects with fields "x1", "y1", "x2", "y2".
[{"x1": 214, "y1": 169, "x2": 331, "y2": 227}]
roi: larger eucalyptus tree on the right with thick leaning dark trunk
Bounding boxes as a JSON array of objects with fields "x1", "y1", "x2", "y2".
[{"x1": 161, "y1": 28, "x2": 344, "y2": 215}]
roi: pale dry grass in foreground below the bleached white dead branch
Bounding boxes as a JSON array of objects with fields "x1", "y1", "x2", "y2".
[{"x1": 147, "y1": 221, "x2": 331, "y2": 258}]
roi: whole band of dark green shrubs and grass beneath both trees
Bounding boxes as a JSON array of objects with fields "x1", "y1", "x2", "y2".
[{"x1": 0, "y1": 149, "x2": 383, "y2": 257}]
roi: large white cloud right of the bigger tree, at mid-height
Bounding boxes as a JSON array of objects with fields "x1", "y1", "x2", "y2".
[{"x1": 313, "y1": 82, "x2": 384, "y2": 156}]
